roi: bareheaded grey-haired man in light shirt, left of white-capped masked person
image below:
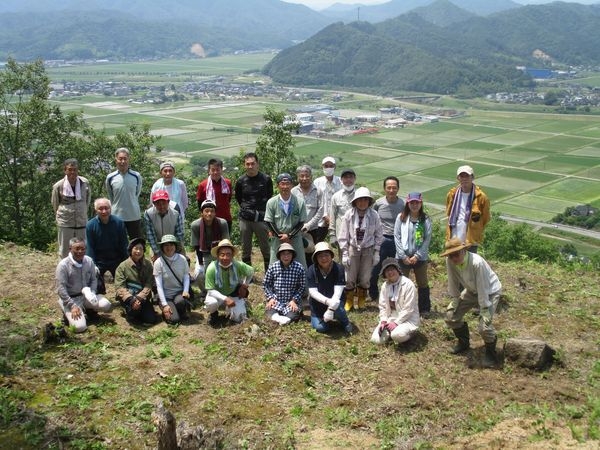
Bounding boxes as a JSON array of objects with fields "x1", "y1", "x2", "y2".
[{"x1": 292, "y1": 165, "x2": 323, "y2": 266}]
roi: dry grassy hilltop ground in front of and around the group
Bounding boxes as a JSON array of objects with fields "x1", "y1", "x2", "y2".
[{"x1": 0, "y1": 243, "x2": 600, "y2": 449}]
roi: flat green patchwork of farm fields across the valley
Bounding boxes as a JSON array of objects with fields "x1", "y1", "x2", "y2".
[{"x1": 50, "y1": 55, "x2": 600, "y2": 227}]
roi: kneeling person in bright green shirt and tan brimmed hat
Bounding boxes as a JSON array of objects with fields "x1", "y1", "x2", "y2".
[{"x1": 204, "y1": 239, "x2": 254, "y2": 325}]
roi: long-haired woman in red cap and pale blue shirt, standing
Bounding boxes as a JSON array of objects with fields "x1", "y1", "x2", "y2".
[{"x1": 394, "y1": 192, "x2": 432, "y2": 315}]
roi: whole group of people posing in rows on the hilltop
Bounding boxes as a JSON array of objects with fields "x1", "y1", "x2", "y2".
[{"x1": 52, "y1": 148, "x2": 501, "y2": 368}]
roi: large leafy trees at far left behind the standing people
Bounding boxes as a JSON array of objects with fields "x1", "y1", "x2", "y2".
[{"x1": 0, "y1": 59, "x2": 160, "y2": 249}]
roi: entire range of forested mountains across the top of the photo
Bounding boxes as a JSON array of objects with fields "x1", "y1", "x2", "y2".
[{"x1": 0, "y1": 0, "x2": 600, "y2": 95}]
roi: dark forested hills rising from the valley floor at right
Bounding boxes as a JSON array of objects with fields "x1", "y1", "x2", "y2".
[{"x1": 265, "y1": 2, "x2": 600, "y2": 95}]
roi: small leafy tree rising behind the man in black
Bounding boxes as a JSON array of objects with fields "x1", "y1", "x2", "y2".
[{"x1": 256, "y1": 106, "x2": 300, "y2": 179}]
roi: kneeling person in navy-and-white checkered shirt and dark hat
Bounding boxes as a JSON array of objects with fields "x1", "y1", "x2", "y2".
[{"x1": 263, "y1": 243, "x2": 306, "y2": 325}]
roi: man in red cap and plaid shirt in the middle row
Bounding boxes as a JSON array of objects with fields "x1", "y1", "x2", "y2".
[{"x1": 144, "y1": 191, "x2": 183, "y2": 262}]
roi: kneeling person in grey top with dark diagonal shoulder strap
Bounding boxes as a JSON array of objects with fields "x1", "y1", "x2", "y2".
[{"x1": 154, "y1": 234, "x2": 190, "y2": 323}]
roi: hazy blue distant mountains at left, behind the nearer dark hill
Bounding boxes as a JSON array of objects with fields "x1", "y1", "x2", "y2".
[{"x1": 0, "y1": 0, "x2": 331, "y2": 59}]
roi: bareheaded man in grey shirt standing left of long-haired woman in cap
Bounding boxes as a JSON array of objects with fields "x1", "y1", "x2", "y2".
[{"x1": 369, "y1": 176, "x2": 404, "y2": 300}]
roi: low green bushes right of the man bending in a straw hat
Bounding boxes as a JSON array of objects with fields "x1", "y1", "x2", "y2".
[{"x1": 484, "y1": 213, "x2": 560, "y2": 262}]
